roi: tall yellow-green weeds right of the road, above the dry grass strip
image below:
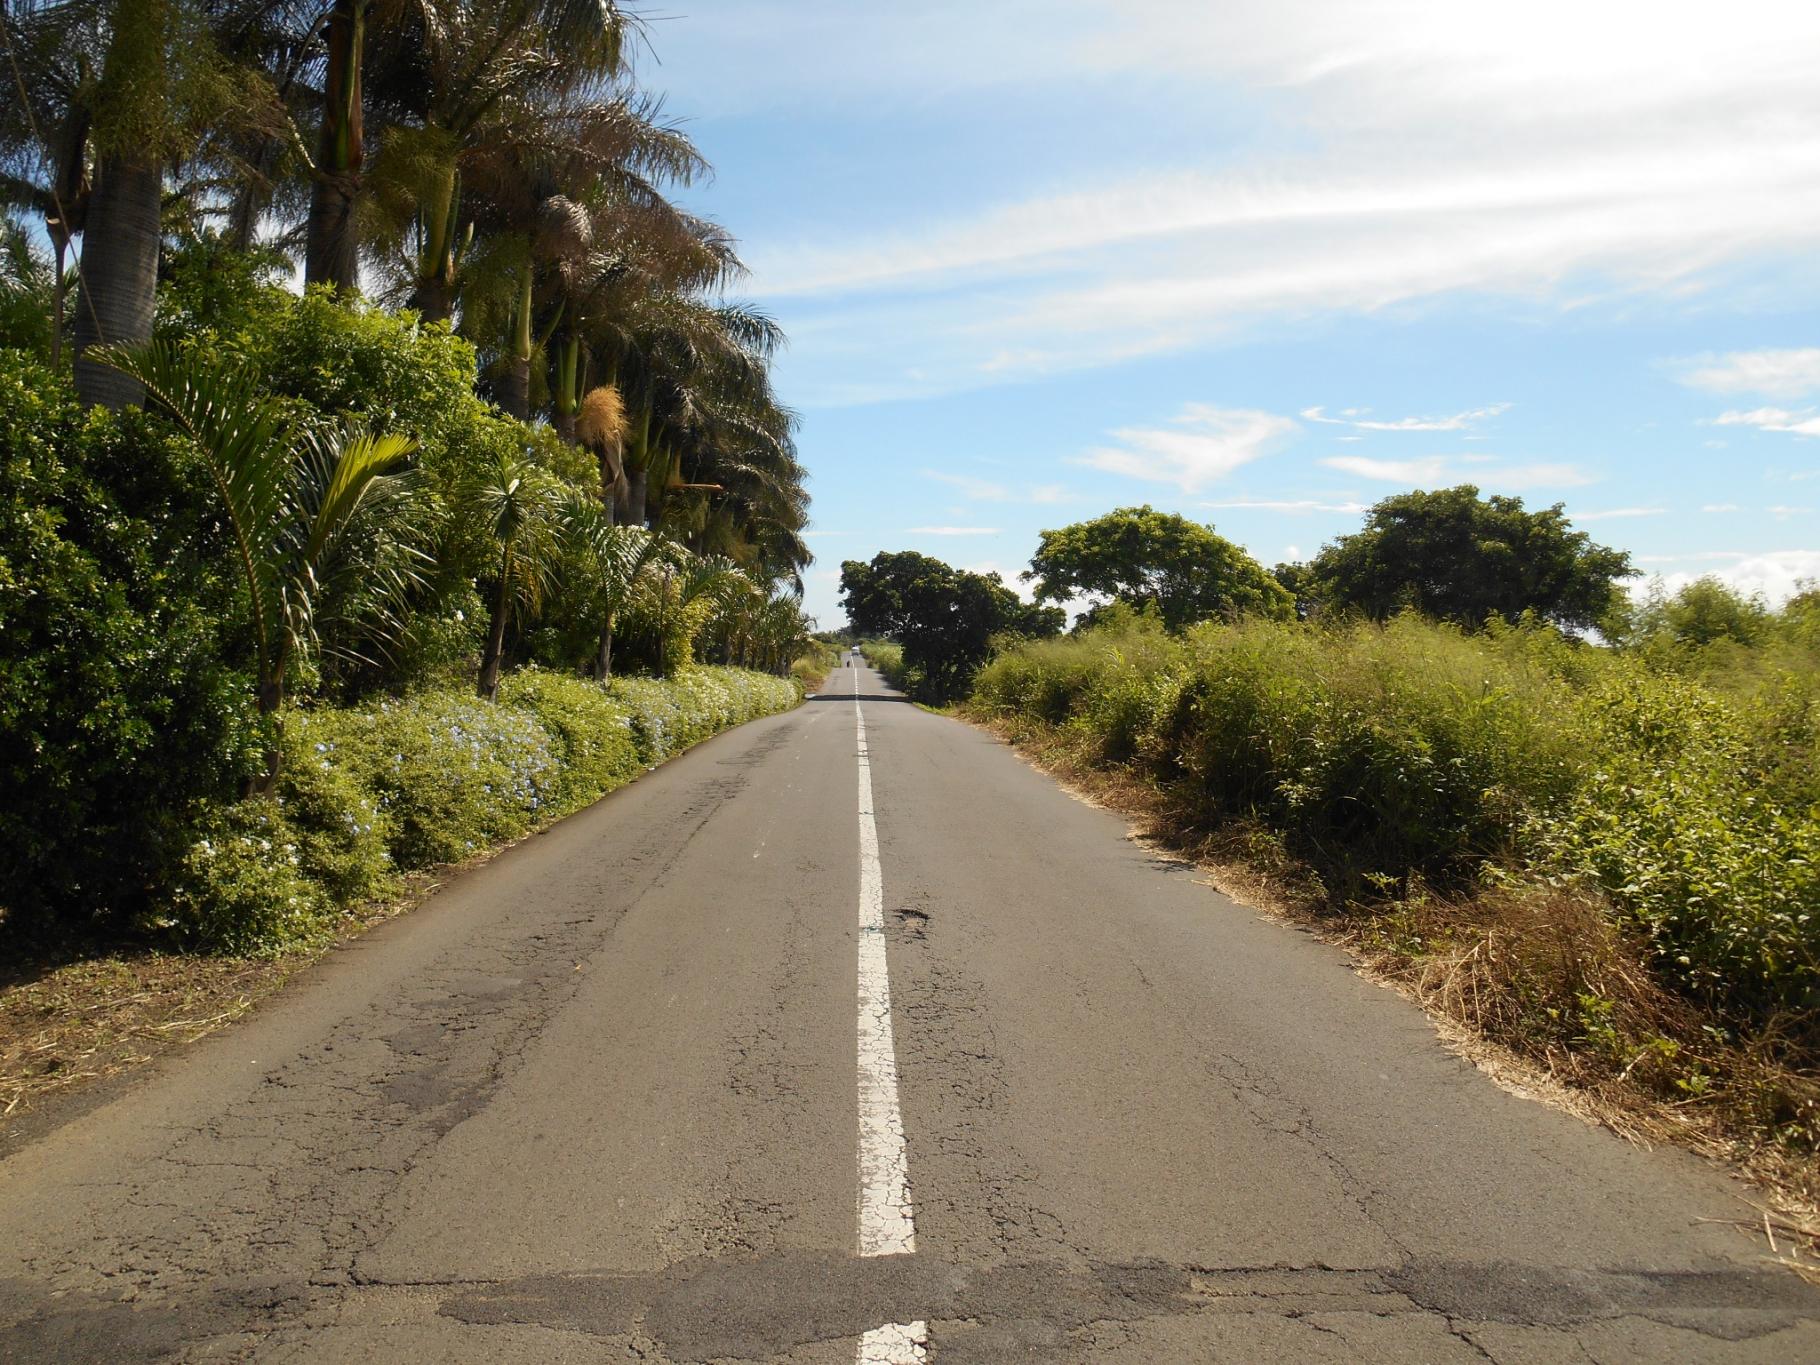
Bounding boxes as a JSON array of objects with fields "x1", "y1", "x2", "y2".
[{"x1": 974, "y1": 617, "x2": 1820, "y2": 1047}]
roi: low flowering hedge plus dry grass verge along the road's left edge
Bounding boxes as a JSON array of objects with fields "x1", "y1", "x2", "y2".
[{"x1": 0, "y1": 664, "x2": 814, "y2": 1147}]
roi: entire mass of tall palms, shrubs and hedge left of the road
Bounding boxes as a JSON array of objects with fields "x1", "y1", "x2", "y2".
[{"x1": 0, "y1": 0, "x2": 828, "y2": 976}]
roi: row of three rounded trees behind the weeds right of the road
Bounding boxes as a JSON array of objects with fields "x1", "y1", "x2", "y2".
[{"x1": 841, "y1": 484, "x2": 1659, "y2": 701}]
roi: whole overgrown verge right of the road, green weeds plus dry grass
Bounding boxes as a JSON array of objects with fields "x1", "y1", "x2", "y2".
[{"x1": 968, "y1": 615, "x2": 1820, "y2": 1236}]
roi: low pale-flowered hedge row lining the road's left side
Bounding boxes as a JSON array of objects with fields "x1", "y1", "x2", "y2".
[{"x1": 158, "y1": 668, "x2": 801, "y2": 952}]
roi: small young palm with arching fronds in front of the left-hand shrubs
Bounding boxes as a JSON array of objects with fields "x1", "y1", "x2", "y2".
[{"x1": 101, "y1": 342, "x2": 417, "y2": 792}]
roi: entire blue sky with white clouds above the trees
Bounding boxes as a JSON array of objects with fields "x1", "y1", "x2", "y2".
[{"x1": 644, "y1": 0, "x2": 1820, "y2": 626}]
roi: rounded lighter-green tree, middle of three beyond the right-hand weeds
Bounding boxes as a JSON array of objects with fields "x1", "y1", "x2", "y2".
[{"x1": 1023, "y1": 506, "x2": 1294, "y2": 630}]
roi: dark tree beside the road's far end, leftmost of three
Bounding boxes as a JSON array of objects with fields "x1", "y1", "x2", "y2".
[{"x1": 841, "y1": 550, "x2": 1067, "y2": 703}]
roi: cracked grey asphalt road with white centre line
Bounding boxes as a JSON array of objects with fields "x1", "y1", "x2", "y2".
[{"x1": 0, "y1": 670, "x2": 1820, "y2": 1363}]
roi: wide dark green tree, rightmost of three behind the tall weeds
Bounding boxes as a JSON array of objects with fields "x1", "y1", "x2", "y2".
[{"x1": 1309, "y1": 484, "x2": 1636, "y2": 630}]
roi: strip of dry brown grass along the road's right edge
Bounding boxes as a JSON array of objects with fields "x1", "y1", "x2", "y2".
[{"x1": 968, "y1": 715, "x2": 1820, "y2": 1283}]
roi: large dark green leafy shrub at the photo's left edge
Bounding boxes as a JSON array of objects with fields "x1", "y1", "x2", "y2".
[{"x1": 0, "y1": 351, "x2": 260, "y2": 928}]
